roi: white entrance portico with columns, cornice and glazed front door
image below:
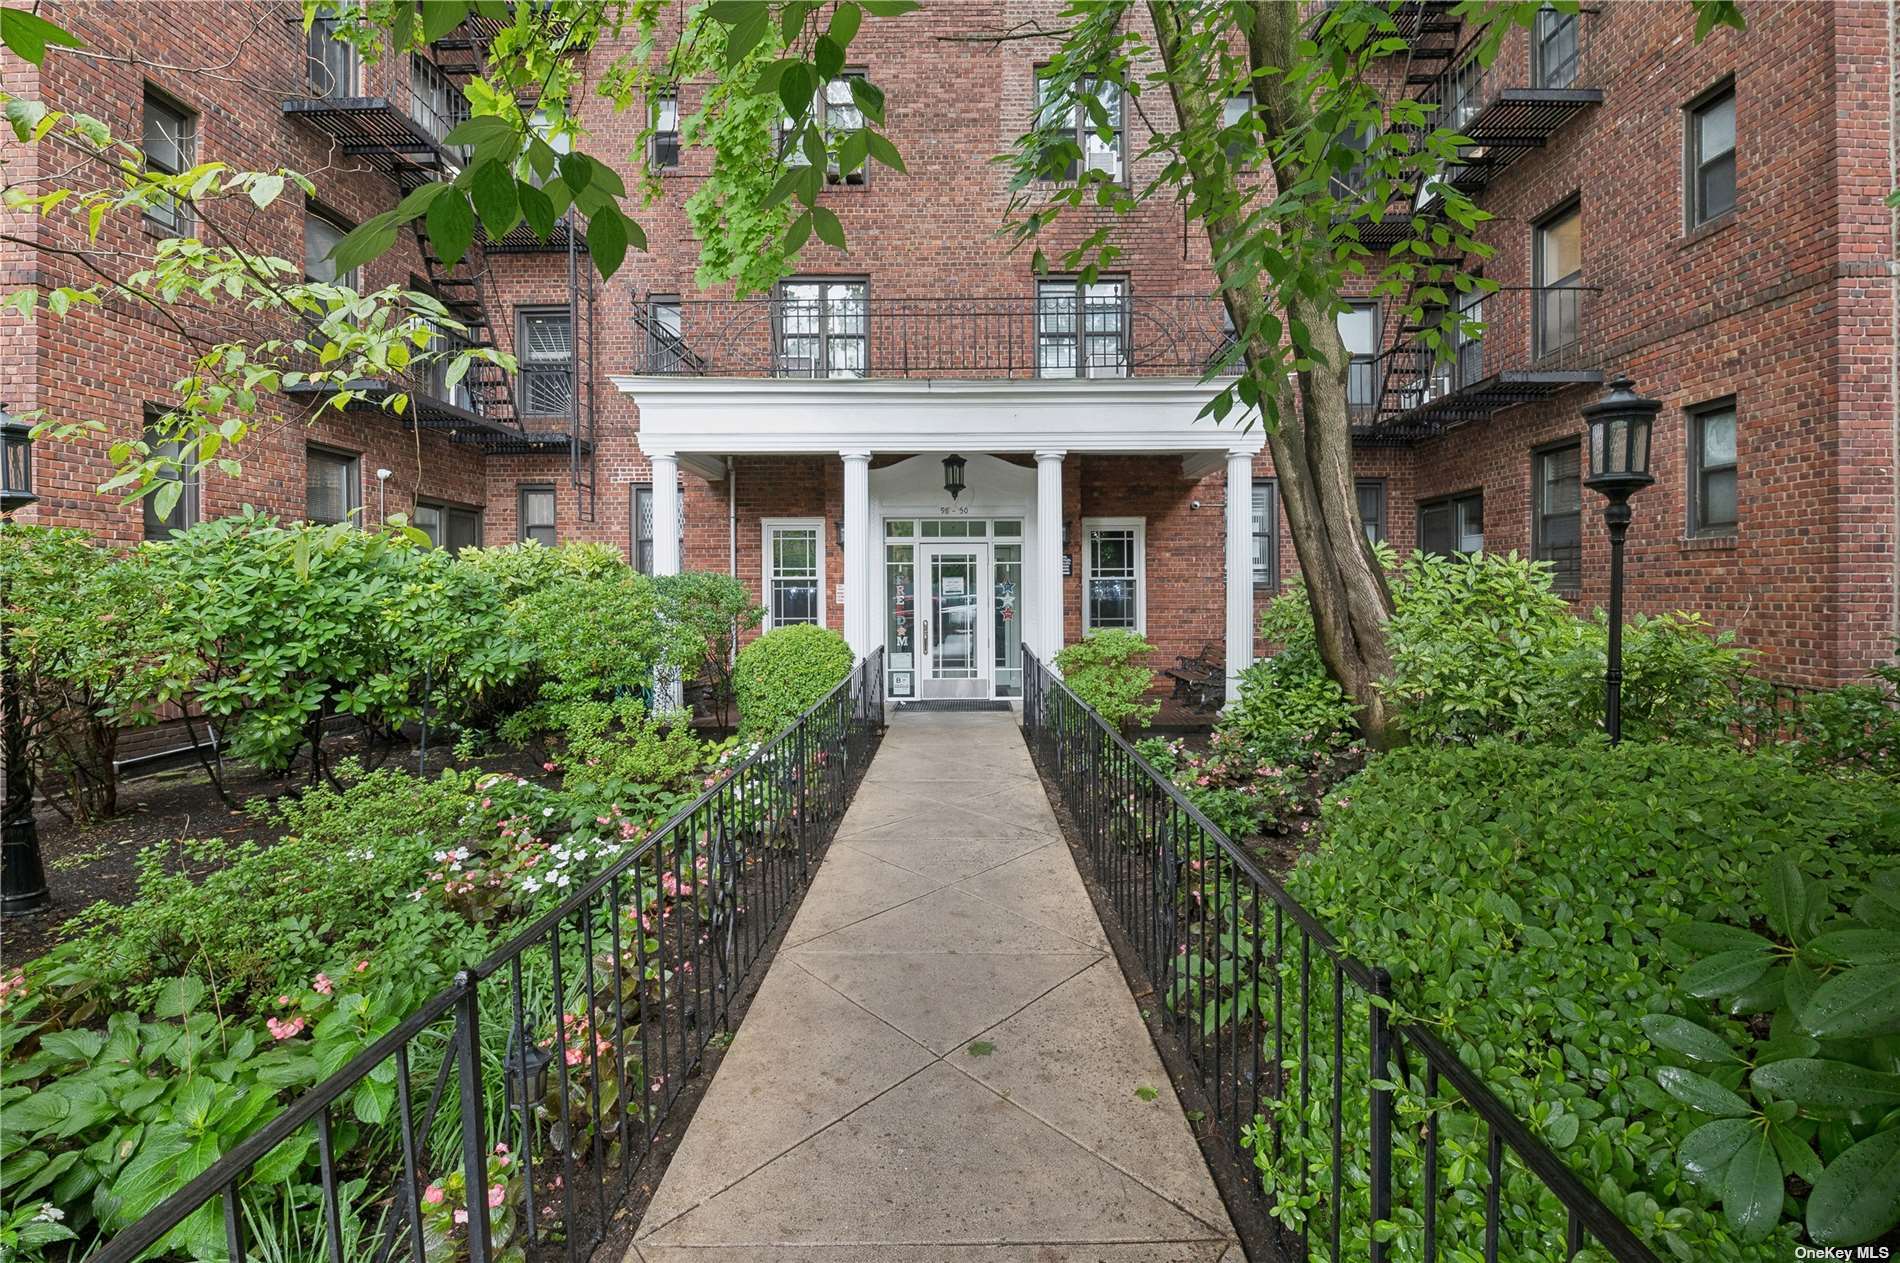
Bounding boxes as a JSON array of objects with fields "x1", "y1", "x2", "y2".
[{"x1": 614, "y1": 374, "x2": 1264, "y2": 697}]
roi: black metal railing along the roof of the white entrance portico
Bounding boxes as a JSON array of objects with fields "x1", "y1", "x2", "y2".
[{"x1": 633, "y1": 294, "x2": 1231, "y2": 378}]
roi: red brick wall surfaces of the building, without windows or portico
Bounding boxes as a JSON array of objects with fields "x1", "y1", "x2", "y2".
[{"x1": 0, "y1": 0, "x2": 1900, "y2": 682}]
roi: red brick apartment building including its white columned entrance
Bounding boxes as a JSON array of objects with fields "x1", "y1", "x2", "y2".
[{"x1": 0, "y1": 0, "x2": 1900, "y2": 695}]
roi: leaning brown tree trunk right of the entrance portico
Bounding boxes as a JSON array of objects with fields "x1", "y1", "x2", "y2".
[{"x1": 1148, "y1": 0, "x2": 1397, "y2": 746}]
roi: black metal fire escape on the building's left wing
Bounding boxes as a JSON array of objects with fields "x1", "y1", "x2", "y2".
[{"x1": 283, "y1": 17, "x2": 597, "y2": 522}]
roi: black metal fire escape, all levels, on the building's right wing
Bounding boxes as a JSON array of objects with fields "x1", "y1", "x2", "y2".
[{"x1": 1349, "y1": 0, "x2": 1604, "y2": 443}]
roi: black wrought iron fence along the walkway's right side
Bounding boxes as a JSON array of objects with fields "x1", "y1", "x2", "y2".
[{"x1": 1022, "y1": 651, "x2": 1657, "y2": 1263}]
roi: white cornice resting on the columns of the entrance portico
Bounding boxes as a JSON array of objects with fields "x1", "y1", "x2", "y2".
[{"x1": 610, "y1": 376, "x2": 1265, "y2": 454}]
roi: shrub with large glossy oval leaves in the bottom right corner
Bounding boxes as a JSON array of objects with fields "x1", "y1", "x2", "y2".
[{"x1": 1644, "y1": 860, "x2": 1900, "y2": 1246}]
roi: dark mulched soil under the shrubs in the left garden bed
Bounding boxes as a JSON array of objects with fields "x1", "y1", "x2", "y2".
[{"x1": 0, "y1": 737, "x2": 543, "y2": 967}]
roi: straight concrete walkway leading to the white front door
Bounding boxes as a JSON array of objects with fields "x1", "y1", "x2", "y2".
[{"x1": 629, "y1": 712, "x2": 1243, "y2": 1263}]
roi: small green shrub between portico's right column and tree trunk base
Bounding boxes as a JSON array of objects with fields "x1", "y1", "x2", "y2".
[{"x1": 1220, "y1": 589, "x2": 1357, "y2": 763}]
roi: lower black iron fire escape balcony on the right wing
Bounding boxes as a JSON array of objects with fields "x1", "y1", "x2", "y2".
[{"x1": 1347, "y1": 285, "x2": 1604, "y2": 437}]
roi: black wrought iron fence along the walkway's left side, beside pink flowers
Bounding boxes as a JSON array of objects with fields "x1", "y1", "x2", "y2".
[{"x1": 89, "y1": 650, "x2": 884, "y2": 1263}]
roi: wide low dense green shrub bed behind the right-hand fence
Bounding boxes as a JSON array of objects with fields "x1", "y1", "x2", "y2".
[{"x1": 1256, "y1": 741, "x2": 1900, "y2": 1261}]
